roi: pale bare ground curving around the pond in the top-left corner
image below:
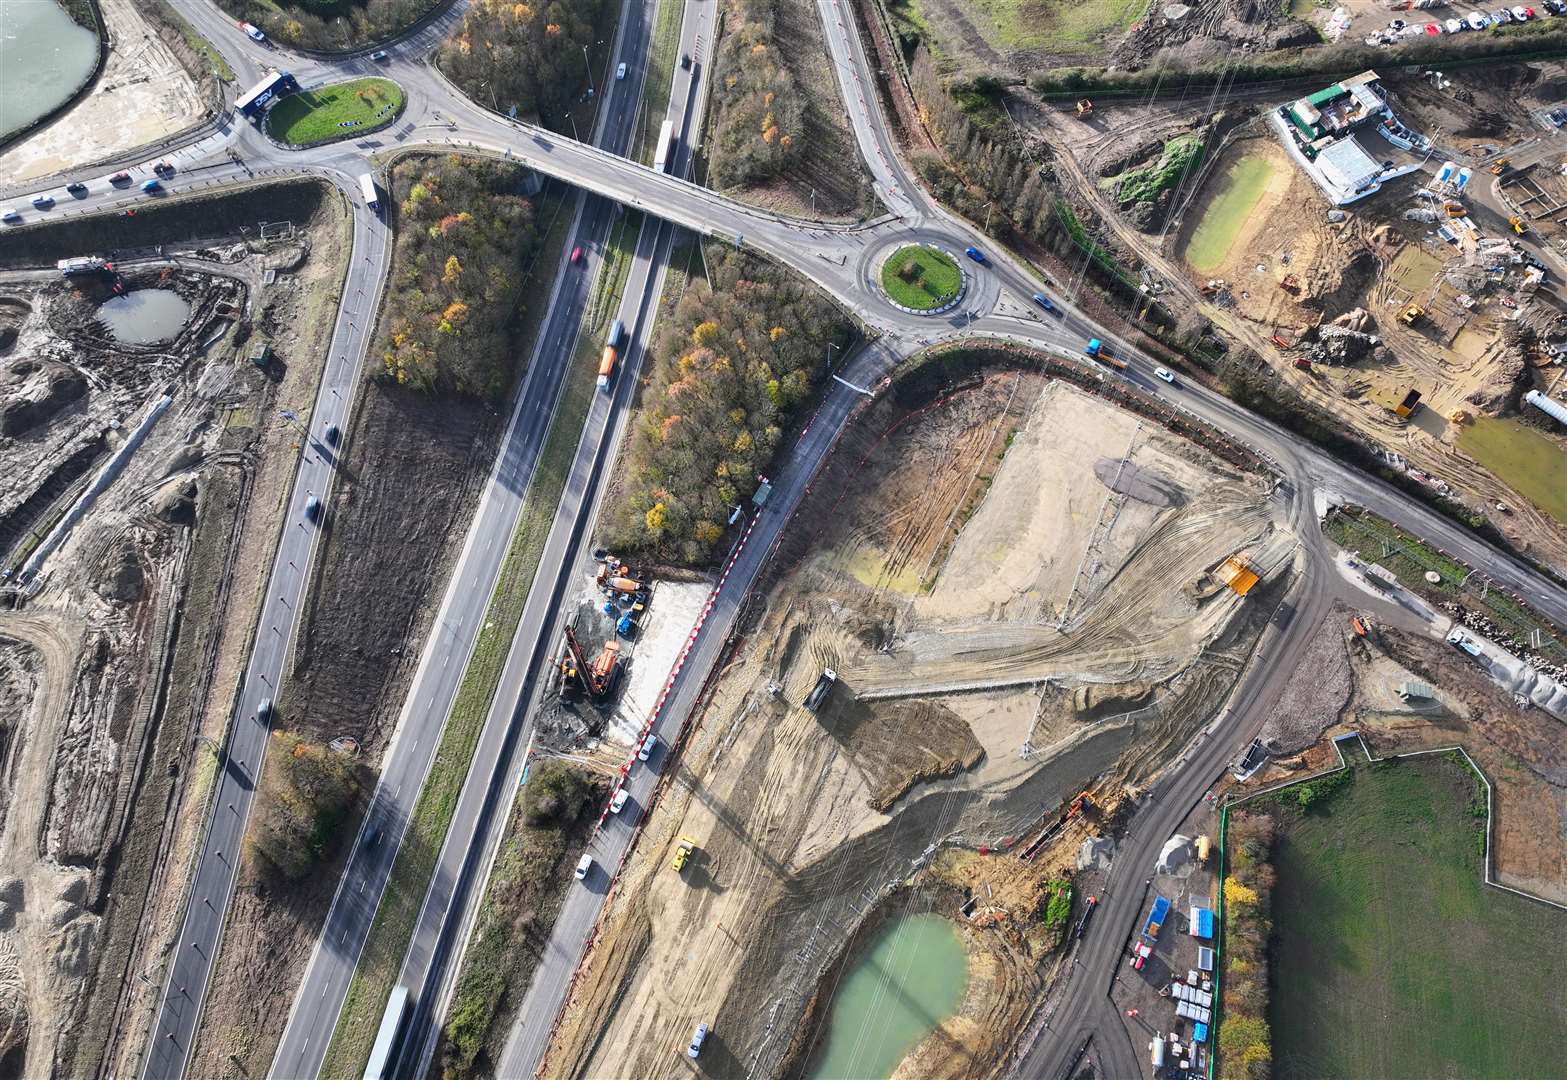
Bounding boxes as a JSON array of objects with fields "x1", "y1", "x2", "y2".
[{"x1": 0, "y1": 0, "x2": 207, "y2": 185}]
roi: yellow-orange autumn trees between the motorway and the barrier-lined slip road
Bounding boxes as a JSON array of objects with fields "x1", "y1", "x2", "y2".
[{"x1": 603, "y1": 248, "x2": 854, "y2": 566}]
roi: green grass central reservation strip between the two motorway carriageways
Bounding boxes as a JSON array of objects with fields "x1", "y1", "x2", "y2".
[{"x1": 311, "y1": 195, "x2": 599, "y2": 1077}]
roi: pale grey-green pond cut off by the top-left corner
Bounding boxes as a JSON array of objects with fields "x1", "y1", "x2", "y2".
[{"x1": 0, "y1": 0, "x2": 97, "y2": 135}]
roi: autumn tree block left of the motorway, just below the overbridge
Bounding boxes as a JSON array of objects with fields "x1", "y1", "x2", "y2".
[{"x1": 378, "y1": 154, "x2": 539, "y2": 400}]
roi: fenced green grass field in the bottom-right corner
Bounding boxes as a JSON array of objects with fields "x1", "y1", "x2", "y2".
[{"x1": 1271, "y1": 756, "x2": 1567, "y2": 1080}]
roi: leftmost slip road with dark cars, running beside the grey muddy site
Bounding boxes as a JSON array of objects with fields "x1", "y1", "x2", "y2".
[{"x1": 143, "y1": 170, "x2": 390, "y2": 1078}]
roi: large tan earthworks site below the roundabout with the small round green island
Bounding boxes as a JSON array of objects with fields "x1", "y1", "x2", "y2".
[{"x1": 544, "y1": 357, "x2": 1296, "y2": 1077}]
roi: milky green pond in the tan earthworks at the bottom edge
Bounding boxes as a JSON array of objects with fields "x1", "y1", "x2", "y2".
[{"x1": 810, "y1": 915, "x2": 968, "y2": 1080}]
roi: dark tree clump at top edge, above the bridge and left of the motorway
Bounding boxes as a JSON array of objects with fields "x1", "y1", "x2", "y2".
[{"x1": 440, "y1": 0, "x2": 605, "y2": 125}]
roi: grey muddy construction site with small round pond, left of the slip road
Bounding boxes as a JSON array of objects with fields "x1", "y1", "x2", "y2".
[{"x1": 0, "y1": 185, "x2": 343, "y2": 1077}]
